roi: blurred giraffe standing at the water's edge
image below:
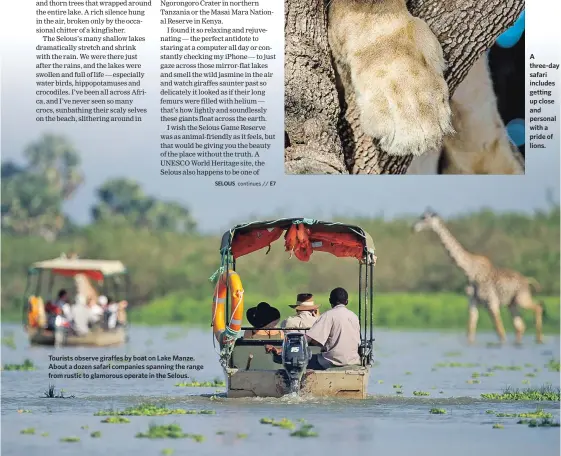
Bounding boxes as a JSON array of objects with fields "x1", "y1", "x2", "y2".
[{"x1": 413, "y1": 210, "x2": 544, "y2": 343}]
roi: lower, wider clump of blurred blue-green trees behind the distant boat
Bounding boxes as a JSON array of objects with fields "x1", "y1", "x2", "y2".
[{"x1": 92, "y1": 178, "x2": 196, "y2": 233}]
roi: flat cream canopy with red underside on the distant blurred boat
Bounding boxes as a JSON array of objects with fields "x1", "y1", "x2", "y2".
[{"x1": 29, "y1": 257, "x2": 127, "y2": 281}]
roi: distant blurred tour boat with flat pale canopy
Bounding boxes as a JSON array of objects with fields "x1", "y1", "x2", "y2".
[{"x1": 23, "y1": 254, "x2": 130, "y2": 347}]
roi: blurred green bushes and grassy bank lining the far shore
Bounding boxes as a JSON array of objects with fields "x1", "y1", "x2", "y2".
[{"x1": 1, "y1": 207, "x2": 560, "y2": 334}]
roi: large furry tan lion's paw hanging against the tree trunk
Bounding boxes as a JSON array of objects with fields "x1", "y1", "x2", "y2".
[{"x1": 332, "y1": 10, "x2": 454, "y2": 156}]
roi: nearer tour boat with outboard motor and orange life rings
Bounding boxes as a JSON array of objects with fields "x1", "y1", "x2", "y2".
[{"x1": 212, "y1": 218, "x2": 376, "y2": 399}]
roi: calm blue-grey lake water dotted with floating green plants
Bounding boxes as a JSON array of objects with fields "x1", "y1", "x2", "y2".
[{"x1": 1, "y1": 325, "x2": 560, "y2": 456}]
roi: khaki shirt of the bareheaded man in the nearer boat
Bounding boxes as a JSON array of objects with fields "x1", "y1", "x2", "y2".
[{"x1": 306, "y1": 304, "x2": 360, "y2": 367}]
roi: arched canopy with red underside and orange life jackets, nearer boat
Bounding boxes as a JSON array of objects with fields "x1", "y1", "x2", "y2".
[{"x1": 220, "y1": 218, "x2": 374, "y2": 263}]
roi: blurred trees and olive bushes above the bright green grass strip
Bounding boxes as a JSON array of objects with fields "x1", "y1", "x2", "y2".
[{"x1": 1, "y1": 136, "x2": 560, "y2": 318}]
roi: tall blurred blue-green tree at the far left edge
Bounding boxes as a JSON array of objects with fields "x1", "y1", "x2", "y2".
[{"x1": 1, "y1": 134, "x2": 83, "y2": 241}]
